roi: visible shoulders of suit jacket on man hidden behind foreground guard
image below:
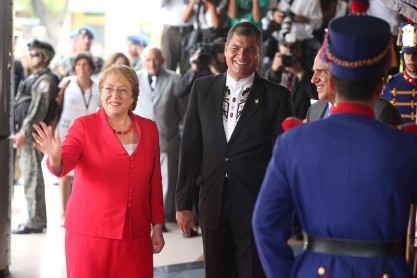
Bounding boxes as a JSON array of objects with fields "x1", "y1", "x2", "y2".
[{"x1": 306, "y1": 98, "x2": 403, "y2": 125}]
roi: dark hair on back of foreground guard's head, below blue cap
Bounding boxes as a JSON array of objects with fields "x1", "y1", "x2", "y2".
[{"x1": 332, "y1": 75, "x2": 382, "y2": 101}]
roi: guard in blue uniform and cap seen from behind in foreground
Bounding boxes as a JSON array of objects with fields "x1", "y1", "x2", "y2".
[{"x1": 252, "y1": 9, "x2": 417, "y2": 278}]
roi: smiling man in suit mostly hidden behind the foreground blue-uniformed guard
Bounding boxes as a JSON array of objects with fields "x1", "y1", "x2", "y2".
[{"x1": 306, "y1": 50, "x2": 403, "y2": 125}]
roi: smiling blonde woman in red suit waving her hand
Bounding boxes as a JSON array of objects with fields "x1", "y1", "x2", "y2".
[{"x1": 33, "y1": 65, "x2": 165, "y2": 278}]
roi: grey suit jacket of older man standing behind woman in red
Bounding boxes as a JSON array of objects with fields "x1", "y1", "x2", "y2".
[{"x1": 133, "y1": 69, "x2": 185, "y2": 153}]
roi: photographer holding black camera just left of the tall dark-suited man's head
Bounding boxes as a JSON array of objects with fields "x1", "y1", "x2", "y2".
[{"x1": 176, "y1": 38, "x2": 227, "y2": 97}]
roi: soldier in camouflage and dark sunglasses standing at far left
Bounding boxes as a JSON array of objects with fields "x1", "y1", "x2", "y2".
[{"x1": 13, "y1": 40, "x2": 58, "y2": 234}]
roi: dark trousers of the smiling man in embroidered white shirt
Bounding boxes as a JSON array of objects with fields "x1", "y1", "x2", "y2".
[{"x1": 202, "y1": 179, "x2": 266, "y2": 278}]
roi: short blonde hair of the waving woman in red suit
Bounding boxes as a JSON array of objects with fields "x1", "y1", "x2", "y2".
[{"x1": 98, "y1": 65, "x2": 139, "y2": 111}]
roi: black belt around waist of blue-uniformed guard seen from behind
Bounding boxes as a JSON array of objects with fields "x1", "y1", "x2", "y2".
[{"x1": 306, "y1": 235, "x2": 404, "y2": 257}]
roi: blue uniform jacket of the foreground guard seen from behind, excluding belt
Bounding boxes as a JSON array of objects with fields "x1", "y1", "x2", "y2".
[{"x1": 253, "y1": 105, "x2": 417, "y2": 278}]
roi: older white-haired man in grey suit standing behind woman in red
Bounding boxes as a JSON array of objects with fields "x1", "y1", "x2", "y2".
[{"x1": 134, "y1": 46, "x2": 185, "y2": 222}]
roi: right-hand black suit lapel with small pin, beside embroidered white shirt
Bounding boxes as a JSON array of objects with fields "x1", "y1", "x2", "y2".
[{"x1": 228, "y1": 73, "x2": 265, "y2": 143}]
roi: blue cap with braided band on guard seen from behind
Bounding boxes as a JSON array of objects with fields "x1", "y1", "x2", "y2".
[{"x1": 324, "y1": 15, "x2": 392, "y2": 80}]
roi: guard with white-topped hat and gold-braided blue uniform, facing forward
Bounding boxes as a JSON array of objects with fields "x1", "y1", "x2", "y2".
[{"x1": 383, "y1": 22, "x2": 417, "y2": 123}]
